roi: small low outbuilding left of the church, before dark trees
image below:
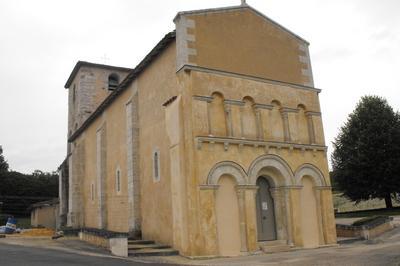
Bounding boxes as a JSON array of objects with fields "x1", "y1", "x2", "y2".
[{"x1": 30, "y1": 198, "x2": 59, "y2": 229}]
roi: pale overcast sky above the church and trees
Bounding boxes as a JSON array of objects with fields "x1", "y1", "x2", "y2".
[{"x1": 0, "y1": 0, "x2": 400, "y2": 173}]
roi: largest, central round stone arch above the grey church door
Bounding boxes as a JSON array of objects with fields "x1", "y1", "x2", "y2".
[{"x1": 248, "y1": 154, "x2": 294, "y2": 187}]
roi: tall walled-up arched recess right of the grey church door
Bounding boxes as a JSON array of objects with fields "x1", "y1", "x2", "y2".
[{"x1": 300, "y1": 176, "x2": 319, "y2": 248}]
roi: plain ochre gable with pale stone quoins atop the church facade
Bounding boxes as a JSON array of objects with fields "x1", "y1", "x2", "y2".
[{"x1": 175, "y1": 6, "x2": 313, "y2": 87}]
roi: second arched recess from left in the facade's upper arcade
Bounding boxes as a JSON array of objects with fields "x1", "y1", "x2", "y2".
[{"x1": 242, "y1": 96, "x2": 257, "y2": 139}]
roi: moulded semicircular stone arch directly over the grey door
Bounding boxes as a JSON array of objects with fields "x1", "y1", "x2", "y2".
[{"x1": 248, "y1": 154, "x2": 294, "y2": 186}]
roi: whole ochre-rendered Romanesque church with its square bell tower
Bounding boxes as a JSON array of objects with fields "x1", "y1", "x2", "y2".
[{"x1": 60, "y1": 1, "x2": 336, "y2": 257}]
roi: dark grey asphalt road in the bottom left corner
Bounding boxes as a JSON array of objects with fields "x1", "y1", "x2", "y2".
[{"x1": 0, "y1": 243, "x2": 170, "y2": 266}]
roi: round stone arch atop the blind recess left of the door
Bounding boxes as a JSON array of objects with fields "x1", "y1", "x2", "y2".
[{"x1": 207, "y1": 161, "x2": 247, "y2": 185}]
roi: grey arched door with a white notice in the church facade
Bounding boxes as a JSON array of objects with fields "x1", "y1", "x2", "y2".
[{"x1": 256, "y1": 177, "x2": 277, "y2": 241}]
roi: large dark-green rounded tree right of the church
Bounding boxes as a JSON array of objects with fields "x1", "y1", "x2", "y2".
[{"x1": 331, "y1": 96, "x2": 400, "y2": 208}]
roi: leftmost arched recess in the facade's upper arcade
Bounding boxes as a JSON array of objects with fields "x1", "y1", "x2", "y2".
[{"x1": 210, "y1": 92, "x2": 227, "y2": 137}]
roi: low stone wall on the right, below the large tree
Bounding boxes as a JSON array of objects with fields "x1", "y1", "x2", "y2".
[{"x1": 336, "y1": 218, "x2": 393, "y2": 239}]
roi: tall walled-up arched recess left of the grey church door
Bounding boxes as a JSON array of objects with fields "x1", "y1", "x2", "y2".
[{"x1": 216, "y1": 175, "x2": 240, "y2": 256}]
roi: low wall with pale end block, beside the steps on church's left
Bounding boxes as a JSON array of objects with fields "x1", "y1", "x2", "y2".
[{"x1": 79, "y1": 228, "x2": 128, "y2": 257}]
